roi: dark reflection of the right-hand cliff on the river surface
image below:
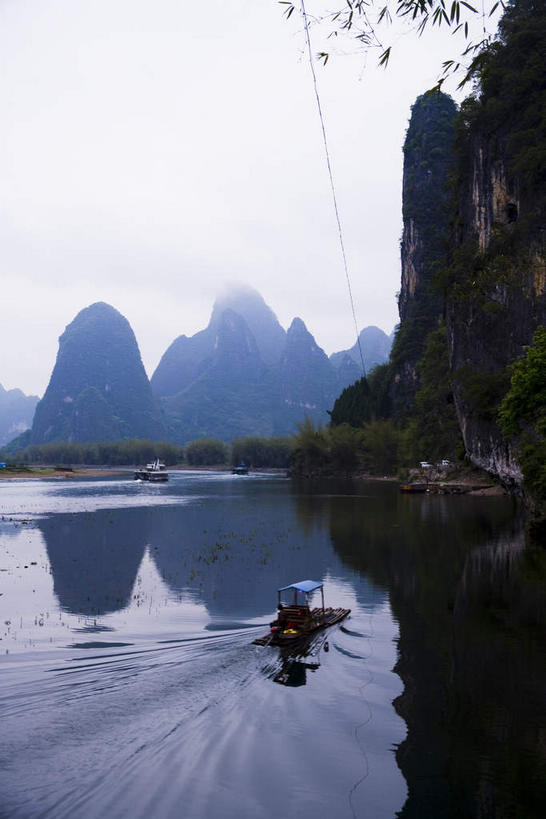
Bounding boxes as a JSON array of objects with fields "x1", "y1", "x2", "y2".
[{"x1": 301, "y1": 480, "x2": 546, "y2": 819}]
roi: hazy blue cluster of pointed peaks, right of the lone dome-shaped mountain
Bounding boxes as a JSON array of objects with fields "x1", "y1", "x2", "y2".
[{"x1": 151, "y1": 287, "x2": 391, "y2": 444}]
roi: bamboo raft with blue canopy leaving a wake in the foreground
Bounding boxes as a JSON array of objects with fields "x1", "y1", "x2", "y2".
[{"x1": 254, "y1": 580, "x2": 351, "y2": 646}]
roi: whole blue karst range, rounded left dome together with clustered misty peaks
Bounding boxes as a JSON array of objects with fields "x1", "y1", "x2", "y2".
[{"x1": 4, "y1": 287, "x2": 391, "y2": 444}]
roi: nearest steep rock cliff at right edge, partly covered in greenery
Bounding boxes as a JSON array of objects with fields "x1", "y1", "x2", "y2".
[{"x1": 447, "y1": 0, "x2": 546, "y2": 485}]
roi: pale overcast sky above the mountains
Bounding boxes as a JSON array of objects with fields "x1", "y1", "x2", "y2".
[{"x1": 0, "y1": 0, "x2": 492, "y2": 395}]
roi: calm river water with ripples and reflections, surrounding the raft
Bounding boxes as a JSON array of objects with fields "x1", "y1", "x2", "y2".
[{"x1": 0, "y1": 472, "x2": 546, "y2": 819}]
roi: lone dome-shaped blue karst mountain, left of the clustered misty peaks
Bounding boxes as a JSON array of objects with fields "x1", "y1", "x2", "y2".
[{"x1": 30, "y1": 302, "x2": 165, "y2": 444}]
